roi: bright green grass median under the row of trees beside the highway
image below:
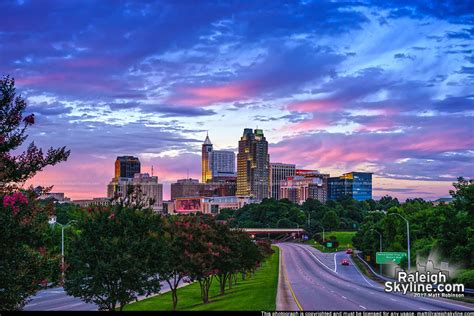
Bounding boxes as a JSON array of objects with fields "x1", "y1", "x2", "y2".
[{"x1": 124, "y1": 246, "x2": 279, "y2": 311}]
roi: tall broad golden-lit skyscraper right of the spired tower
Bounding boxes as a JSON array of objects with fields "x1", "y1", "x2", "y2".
[{"x1": 237, "y1": 128, "x2": 270, "y2": 200}]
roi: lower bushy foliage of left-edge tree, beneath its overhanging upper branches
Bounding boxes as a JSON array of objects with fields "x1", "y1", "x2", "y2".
[{"x1": 0, "y1": 191, "x2": 52, "y2": 310}]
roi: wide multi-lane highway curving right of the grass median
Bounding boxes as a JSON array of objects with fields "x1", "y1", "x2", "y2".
[{"x1": 278, "y1": 243, "x2": 474, "y2": 311}]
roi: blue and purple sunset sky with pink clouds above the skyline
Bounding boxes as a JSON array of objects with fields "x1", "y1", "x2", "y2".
[{"x1": 0, "y1": 0, "x2": 474, "y2": 200}]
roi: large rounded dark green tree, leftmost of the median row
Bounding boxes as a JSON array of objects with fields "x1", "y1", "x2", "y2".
[{"x1": 65, "y1": 206, "x2": 163, "y2": 311}]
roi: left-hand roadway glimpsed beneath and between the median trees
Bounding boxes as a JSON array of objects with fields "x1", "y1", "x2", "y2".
[{"x1": 23, "y1": 282, "x2": 186, "y2": 311}]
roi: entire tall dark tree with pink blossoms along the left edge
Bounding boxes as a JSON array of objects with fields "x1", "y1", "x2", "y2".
[{"x1": 0, "y1": 77, "x2": 69, "y2": 310}]
